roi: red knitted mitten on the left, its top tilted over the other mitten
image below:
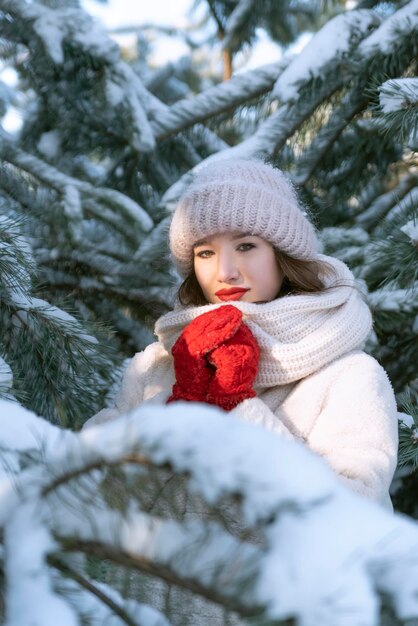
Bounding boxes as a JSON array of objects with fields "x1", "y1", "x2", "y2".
[{"x1": 167, "y1": 304, "x2": 242, "y2": 403}]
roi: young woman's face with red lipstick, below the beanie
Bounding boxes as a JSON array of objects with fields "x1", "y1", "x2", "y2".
[{"x1": 194, "y1": 232, "x2": 283, "y2": 304}]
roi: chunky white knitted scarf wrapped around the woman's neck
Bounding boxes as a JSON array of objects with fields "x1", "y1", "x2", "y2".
[{"x1": 155, "y1": 255, "x2": 372, "y2": 388}]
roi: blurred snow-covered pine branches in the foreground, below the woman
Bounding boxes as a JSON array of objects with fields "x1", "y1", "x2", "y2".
[{"x1": 4, "y1": 401, "x2": 418, "y2": 626}]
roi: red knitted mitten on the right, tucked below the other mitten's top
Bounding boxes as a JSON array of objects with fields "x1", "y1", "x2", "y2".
[{"x1": 206, "y1": 323, "x2": 260, "y2": 411}]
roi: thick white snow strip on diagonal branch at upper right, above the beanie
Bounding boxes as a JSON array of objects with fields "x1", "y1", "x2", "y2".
[{"x1": 272, "y1": 9, "x2": 379, "y2": 103}]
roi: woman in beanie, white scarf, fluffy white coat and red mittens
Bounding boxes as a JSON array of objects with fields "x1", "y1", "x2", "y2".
[{"x1": 82, "y1": 160, "x2": 398, "y2": 508}]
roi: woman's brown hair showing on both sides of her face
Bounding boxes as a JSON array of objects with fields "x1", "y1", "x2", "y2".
[{"x1": 177, "y1": 248, "x2": 342, "y2": 306}]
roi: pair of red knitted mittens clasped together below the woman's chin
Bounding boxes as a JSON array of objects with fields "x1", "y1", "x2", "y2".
[{"x1": 167, "y1": 305, "x2": 259, "y2": 411}]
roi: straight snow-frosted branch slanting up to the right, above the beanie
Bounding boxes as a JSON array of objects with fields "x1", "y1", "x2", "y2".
[{"x1": 151, "y1": 62, "x2": 287, "y2": 140}]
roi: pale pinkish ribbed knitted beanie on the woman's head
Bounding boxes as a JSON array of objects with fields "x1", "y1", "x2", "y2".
[{"x1": 169, "y1": 159, "x2": 318, "y2": 276}]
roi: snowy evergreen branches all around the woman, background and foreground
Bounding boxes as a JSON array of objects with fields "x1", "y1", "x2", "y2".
[{"x1": 0, "y1": 0, "x2": 418, "y2": 626}]
